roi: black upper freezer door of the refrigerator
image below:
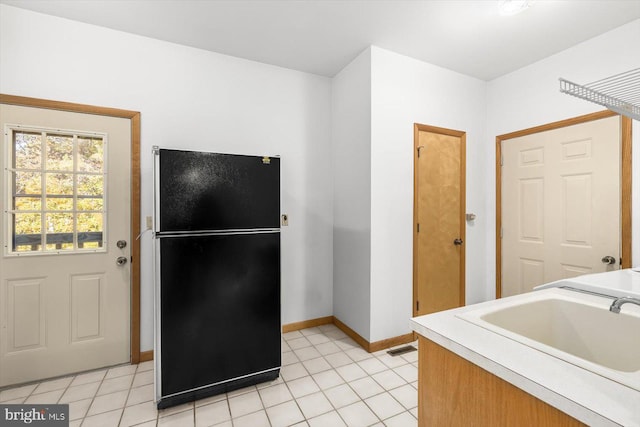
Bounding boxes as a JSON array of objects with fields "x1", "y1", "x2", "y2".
[{"x1": 158, "y1": 149, "x2": 280, "y2": 233}]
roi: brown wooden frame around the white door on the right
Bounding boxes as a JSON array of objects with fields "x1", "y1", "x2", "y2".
[{"x1": 496, "y1": 110, "x2": 632, "y2": 298}]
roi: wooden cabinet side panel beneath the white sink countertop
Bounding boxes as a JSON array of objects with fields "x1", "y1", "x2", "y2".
[{"x1": 418, "y1": 336, "x2": 584, "y2": 427}]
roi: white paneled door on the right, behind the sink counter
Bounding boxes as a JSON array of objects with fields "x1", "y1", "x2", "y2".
[{"x1": 501, "y1": 116, "x2": 621, "y2": 296}]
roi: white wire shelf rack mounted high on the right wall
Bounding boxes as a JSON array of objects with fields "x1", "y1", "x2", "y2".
[{"x1": 560, "y1": 68, "x2": 640, "y2": 121}]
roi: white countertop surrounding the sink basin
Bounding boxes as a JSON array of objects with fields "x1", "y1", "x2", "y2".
[{"x1": 411, "y1": 271, "x2": 640, "y2": 427}]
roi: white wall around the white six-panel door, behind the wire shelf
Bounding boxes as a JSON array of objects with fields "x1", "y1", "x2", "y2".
[{"x1": 483, "y1": 20, "x2": 640, "y2": 296}]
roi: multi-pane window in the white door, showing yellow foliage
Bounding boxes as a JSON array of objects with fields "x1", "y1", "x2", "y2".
[{"x1": 5, "y1": 126, "x2": 107, "y2": 255}]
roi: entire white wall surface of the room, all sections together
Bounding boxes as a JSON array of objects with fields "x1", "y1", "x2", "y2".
[{"x1": 0, "y1": 5, "x2": 640, "y2": 350}]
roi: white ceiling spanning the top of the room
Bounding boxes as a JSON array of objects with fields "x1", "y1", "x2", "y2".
[{"x1": 0, "y1": 0, "x2": 640, "y2": 80}]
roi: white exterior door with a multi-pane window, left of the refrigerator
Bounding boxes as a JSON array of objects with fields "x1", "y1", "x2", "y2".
[{"x1": 0, "y1": 104, "x2": 131, "y2": 387}]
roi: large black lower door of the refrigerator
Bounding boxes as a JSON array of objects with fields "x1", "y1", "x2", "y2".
[{"x1": 156, "y1": 232, "x2": 281, "y2": 408}]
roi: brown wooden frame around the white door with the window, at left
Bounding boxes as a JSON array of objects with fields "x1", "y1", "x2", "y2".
[{"x1": 0, "y1": 94, "x2": 140, "y2": 364}]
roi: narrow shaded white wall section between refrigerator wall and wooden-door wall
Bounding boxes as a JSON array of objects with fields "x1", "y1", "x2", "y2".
[{"x1": 331, "y1": 49, "x2": 371, "y2": 340}]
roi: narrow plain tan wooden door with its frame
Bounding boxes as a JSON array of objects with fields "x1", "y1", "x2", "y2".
[{"x1": 413, "y1": 124, "x2": 465, "y2": 316}]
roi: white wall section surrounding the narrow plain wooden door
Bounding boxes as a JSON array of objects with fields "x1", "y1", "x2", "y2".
[{"x1": 371, "y1": 47, "x2": 487, "y2": 342}]
